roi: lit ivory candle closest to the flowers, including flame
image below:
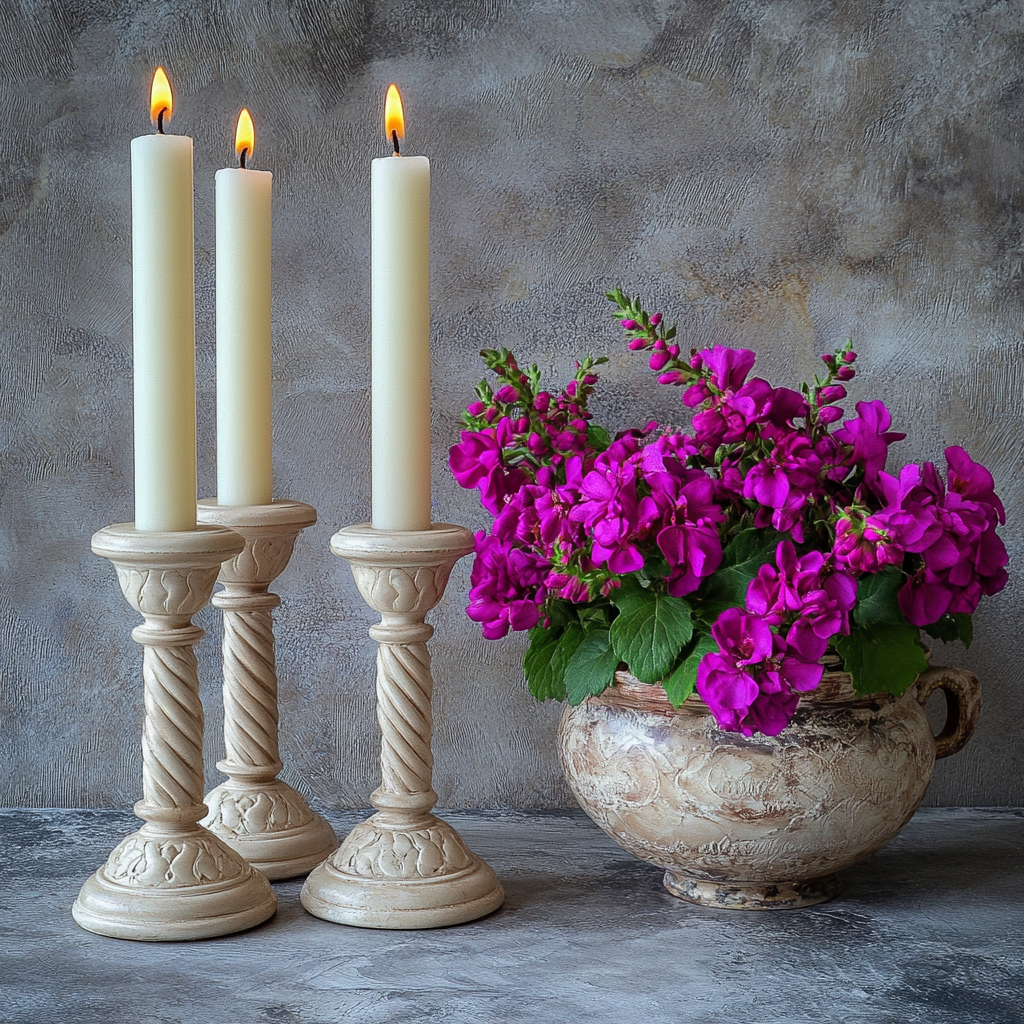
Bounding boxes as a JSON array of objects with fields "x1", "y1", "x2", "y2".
[{"x1": 370, "y1": 85, "x2": 430, "y2": 529}]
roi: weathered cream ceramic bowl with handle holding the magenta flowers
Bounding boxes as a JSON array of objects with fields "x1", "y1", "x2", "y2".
[{"x1": 558, "y1": 668, "x2": 981, "y2": 910}]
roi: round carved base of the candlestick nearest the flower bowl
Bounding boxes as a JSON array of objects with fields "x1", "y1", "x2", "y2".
[{"x1": 302, "y1": 814, "x2": 505, "y2": 929}]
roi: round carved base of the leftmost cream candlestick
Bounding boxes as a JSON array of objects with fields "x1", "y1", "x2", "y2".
[{"x1": 72, "y1": 826, "x2": 278, "y2": 942}]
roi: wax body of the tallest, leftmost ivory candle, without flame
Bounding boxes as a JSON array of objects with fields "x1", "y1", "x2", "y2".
[{"x1": 131, "y1": 134, "x2": 196, "y2": 530}]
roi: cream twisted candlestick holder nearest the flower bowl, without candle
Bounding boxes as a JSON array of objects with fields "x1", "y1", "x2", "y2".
[{"x1": 302, "y1": 523, "x2": 505, "y2": 928}]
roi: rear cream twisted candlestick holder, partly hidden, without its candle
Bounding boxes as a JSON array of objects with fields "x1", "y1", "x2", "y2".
[{"x1": 197, "y1": 501, "x2": 338, "y2": 880}]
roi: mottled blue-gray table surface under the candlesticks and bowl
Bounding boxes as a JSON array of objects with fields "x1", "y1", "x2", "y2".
[{"x1": 0, "y1": 808, "x2": 1024, "y2": 1024}]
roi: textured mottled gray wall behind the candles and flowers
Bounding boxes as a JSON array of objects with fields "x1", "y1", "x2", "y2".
[{"x1": 0, "y1": 0, "x2": 1024, "y2": 806}]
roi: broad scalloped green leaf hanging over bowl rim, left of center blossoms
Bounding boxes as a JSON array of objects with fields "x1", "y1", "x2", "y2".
[{"x1": 609, "y1": 588, "x2": 693, "y2": 683}]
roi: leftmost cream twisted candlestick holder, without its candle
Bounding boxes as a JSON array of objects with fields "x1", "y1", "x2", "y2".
[{"x1": 72, "y1": 523, "x2": 278, "y2": 942}]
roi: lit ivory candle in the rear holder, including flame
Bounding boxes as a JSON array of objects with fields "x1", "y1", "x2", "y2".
[{"x1": 216, "y1": 110, "x2": 273, "y2": 505}]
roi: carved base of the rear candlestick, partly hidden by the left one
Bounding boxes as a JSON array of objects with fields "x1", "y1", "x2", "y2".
[{"x1": 200, "y1": 779, "x2": 338, "y2": 882}]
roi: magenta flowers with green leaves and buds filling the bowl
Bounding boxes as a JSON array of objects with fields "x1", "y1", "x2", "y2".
[{"x1": 450, "y1": 290, "x2": 1007, "y2": 735}]
